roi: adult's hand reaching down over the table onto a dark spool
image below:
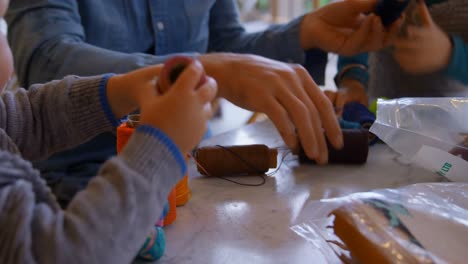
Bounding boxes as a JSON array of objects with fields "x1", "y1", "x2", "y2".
[{"x1": 199, "y1": 53, "x2": 343, "y2": 164}]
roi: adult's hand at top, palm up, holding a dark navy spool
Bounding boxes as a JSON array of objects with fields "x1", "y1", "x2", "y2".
[{"x1": 300, "y1": 0, "x2": 401, "y2": 56}]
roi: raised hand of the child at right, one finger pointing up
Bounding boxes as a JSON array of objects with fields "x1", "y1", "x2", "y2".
[{"x1": 394, "y1": 1, "x2": 452, "y2": 74}]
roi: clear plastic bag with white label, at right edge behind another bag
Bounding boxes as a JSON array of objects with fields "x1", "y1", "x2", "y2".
[{"x1": 370, "y1": 98, "x2": 468, "y2": 181}]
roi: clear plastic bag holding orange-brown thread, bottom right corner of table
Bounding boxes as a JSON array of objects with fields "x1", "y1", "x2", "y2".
[{"x1": 291, "y1": 183, "x2": 468, "y2": 263}]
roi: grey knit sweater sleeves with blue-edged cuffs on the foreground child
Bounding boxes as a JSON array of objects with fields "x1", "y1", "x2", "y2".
[{"x1": 0, "y1": 76, "x2": 185, "y2": 264}]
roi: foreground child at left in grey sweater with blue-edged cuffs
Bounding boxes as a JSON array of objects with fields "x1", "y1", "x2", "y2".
[{"x1": 0, "y1": 0, "x2": 217, "y2": 263}]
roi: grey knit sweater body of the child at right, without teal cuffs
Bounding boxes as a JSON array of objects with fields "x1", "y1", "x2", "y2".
[{"x1": 369, "y1": 0, "x2": 468, "y2": 98}]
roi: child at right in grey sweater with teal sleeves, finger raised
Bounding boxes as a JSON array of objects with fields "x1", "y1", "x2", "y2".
[{"x1": 328, "y1": 0, "x2": 468, "y2": 109}]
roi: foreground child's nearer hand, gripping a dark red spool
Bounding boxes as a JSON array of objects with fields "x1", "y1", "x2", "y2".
[{"x1": 140, "y1": 61, "x2": 217, "y2": 153}]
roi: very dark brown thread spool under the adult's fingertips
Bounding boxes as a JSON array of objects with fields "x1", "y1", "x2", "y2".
[{"x1": 299, "y1": 129, "x2": 369, "y2": 164}]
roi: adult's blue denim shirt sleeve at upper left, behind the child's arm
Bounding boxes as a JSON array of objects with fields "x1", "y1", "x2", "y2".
[{"x1": 5, "y1": 0, "x2": 194, "y2": 87}]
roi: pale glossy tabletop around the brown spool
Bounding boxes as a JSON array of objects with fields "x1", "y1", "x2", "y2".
[{"x1": 158, "y1": 121, "x2": 440, "y2": 264}]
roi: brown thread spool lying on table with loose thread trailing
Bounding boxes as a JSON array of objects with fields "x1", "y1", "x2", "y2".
[{"x1": 194, "y1": 145, "x2": 278, "y2": 176}]
